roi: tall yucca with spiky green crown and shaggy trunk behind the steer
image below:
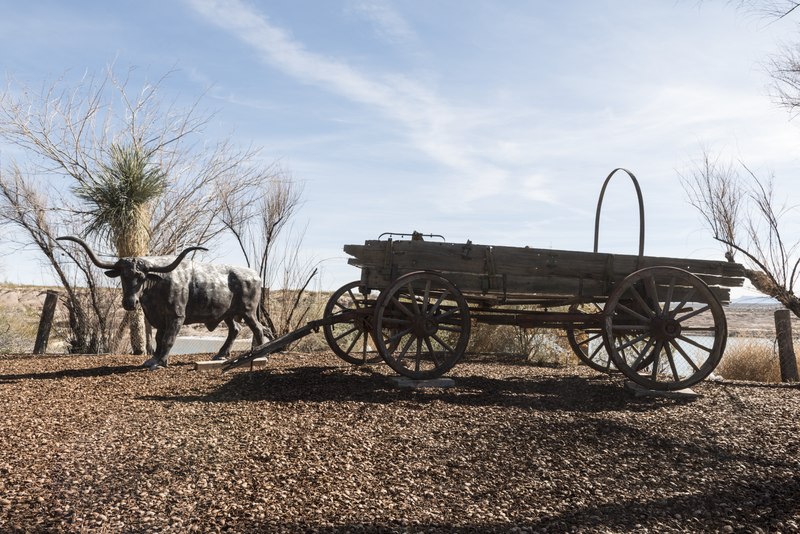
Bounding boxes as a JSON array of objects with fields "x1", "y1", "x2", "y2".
[{"x1": 74, "y1": 144, "x2": 167, "y2": 354}]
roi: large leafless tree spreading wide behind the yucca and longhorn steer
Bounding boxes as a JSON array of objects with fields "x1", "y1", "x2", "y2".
[{"x1": 0, "y1": 68, "x2": 286, "y2": 351}]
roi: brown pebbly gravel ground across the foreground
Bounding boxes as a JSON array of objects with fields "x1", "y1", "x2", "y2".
[{"x1": 0, "y1": 354, "x2": 800, "y2": 532}]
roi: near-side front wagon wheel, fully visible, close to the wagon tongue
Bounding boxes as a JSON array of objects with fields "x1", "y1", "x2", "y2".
[{"x1": 374, "y1": 272, "x2": 470, "y2": 380}]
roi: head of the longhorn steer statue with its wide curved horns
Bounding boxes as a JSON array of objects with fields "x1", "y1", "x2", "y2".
[{"x1": 56, "y1": 236, "x2": 208, "y2": 311}]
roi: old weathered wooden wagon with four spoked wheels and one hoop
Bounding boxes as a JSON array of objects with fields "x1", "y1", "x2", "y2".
[{"x1": 227, "y1": 169, "x2": 744, "y2": 390}]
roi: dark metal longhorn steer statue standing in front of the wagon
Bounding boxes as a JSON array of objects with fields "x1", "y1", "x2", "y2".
[{"x1": 58, "y1": 236, "x2": 264, "y2": 369}]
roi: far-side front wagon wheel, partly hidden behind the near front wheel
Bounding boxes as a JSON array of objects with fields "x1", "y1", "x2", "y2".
[{"x1": 322, "y1": 282, "x2": 380, "y2": 365}]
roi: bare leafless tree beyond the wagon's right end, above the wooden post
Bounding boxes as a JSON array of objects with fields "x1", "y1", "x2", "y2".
[{"x1": 681, "y1": 151, "x2": 800, "y2": 317}]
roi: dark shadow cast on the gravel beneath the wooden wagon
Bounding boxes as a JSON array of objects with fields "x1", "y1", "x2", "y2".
[{"x1": 140, "y1": 367, "x2": 687, "y2": 412}]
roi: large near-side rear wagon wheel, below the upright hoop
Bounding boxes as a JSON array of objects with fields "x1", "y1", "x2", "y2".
[{"x1": 603, "y1": 267, "x2": 728, "y2": 390}]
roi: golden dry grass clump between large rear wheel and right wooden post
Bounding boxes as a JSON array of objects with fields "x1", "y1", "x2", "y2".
[{"x1": 716, "y1": 338, "x2": 781, "y2": 382}]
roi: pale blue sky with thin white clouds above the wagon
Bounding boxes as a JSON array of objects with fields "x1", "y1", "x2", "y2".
[{"x1": 0, "y1": 0, "x2": 800, "y2": 294}]
